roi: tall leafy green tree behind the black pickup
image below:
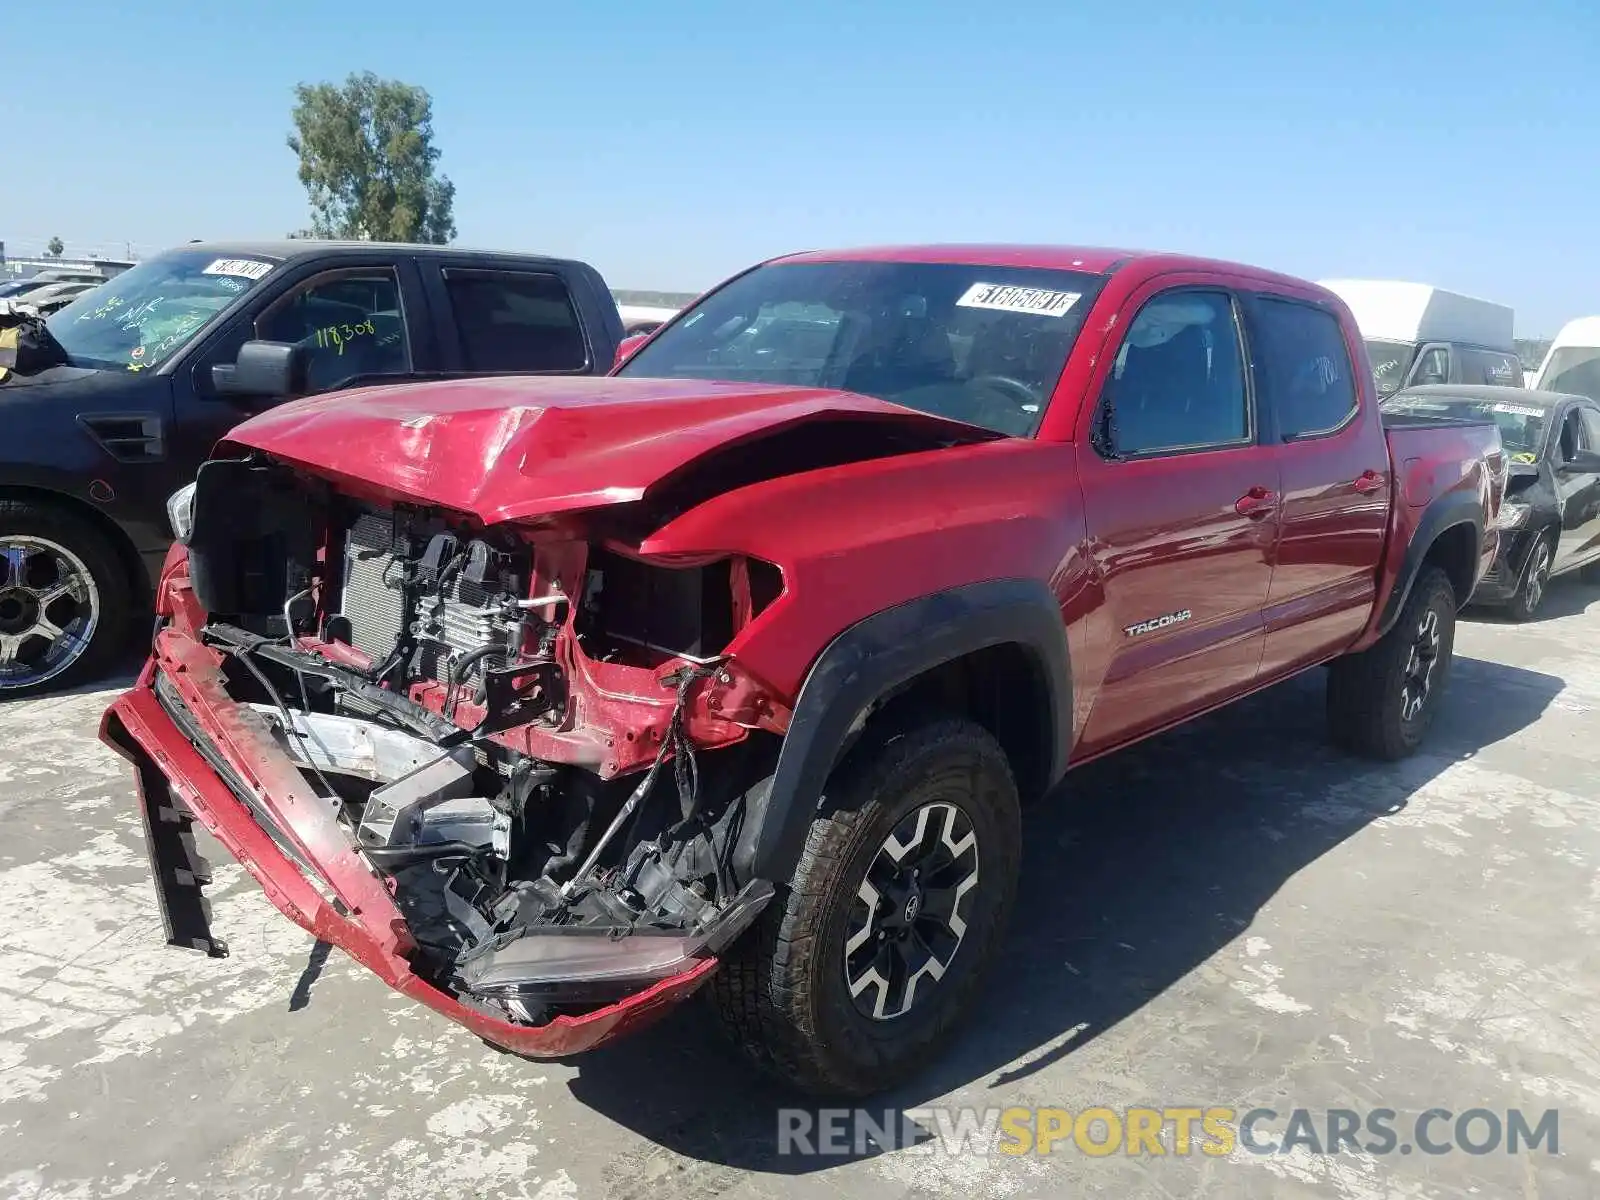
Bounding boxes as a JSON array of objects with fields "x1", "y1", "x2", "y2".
[{"x1": 288, "y1": 70, "x2": 456, "y2": 243}]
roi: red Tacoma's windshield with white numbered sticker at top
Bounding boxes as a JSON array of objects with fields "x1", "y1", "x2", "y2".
[{"x1": 619, "y1": 262, "x2": 1102, "y2": 437}]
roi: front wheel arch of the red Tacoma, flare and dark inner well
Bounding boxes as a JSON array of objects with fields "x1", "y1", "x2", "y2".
[{"x1": 733, "y1": 579, "x2": 1072, "y2": 883}]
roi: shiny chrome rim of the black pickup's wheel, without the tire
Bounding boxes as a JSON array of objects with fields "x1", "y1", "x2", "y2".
[{"x1": 0, "y1": 534, "x2": 101, "y2": 693}]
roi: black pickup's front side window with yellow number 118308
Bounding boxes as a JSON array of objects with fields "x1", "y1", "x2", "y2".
[{"x1": 256, "y1": 267, "x2": 411, "y2": 392}]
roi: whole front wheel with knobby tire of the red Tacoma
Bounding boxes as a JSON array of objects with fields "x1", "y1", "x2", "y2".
[{"x1": 710, "y1": 718, "x2": 1021, "y2": 1096}]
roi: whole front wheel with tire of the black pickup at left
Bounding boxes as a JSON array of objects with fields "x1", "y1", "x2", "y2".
[{"x1": 0, "y1": 501, "x2": 130, "y2": 699}]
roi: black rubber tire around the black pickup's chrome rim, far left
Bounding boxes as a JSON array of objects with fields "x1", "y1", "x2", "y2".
[{"x1": 0, "y1": 499, "x2": 133, "y2": 702}]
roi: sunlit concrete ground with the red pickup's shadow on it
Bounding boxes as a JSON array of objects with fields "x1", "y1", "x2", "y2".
[{"x1": 0, "y1": 584, "x2": 1600, "y2": 1200}]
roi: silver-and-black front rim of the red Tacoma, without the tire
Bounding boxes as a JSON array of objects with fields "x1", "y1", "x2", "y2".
[{"x1": 845, "y1": 802, "x2": 979, "y2": 1021}]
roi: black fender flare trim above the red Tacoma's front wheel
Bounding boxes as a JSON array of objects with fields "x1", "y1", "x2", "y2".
[{"x1": 734, "y1": 579, "x2": 1072, "y2": 883}]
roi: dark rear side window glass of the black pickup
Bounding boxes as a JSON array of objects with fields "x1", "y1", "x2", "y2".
[{"x1": 445, "y1": 269, "x2": 589, "y2": 371}]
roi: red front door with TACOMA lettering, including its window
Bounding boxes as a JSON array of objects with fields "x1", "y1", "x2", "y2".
[{"x1": 1078, "y1": 277, "x2": 1282, "y2": 755}]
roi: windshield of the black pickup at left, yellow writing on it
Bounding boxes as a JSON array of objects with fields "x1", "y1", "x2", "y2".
[{"x1": 46, "y1": 250, "x2": 277, "y2": 371}]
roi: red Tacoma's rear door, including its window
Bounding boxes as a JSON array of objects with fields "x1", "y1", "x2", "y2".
[{"x1": 1248, "y1": 293, "x2": 1392, "y2": 677}]
